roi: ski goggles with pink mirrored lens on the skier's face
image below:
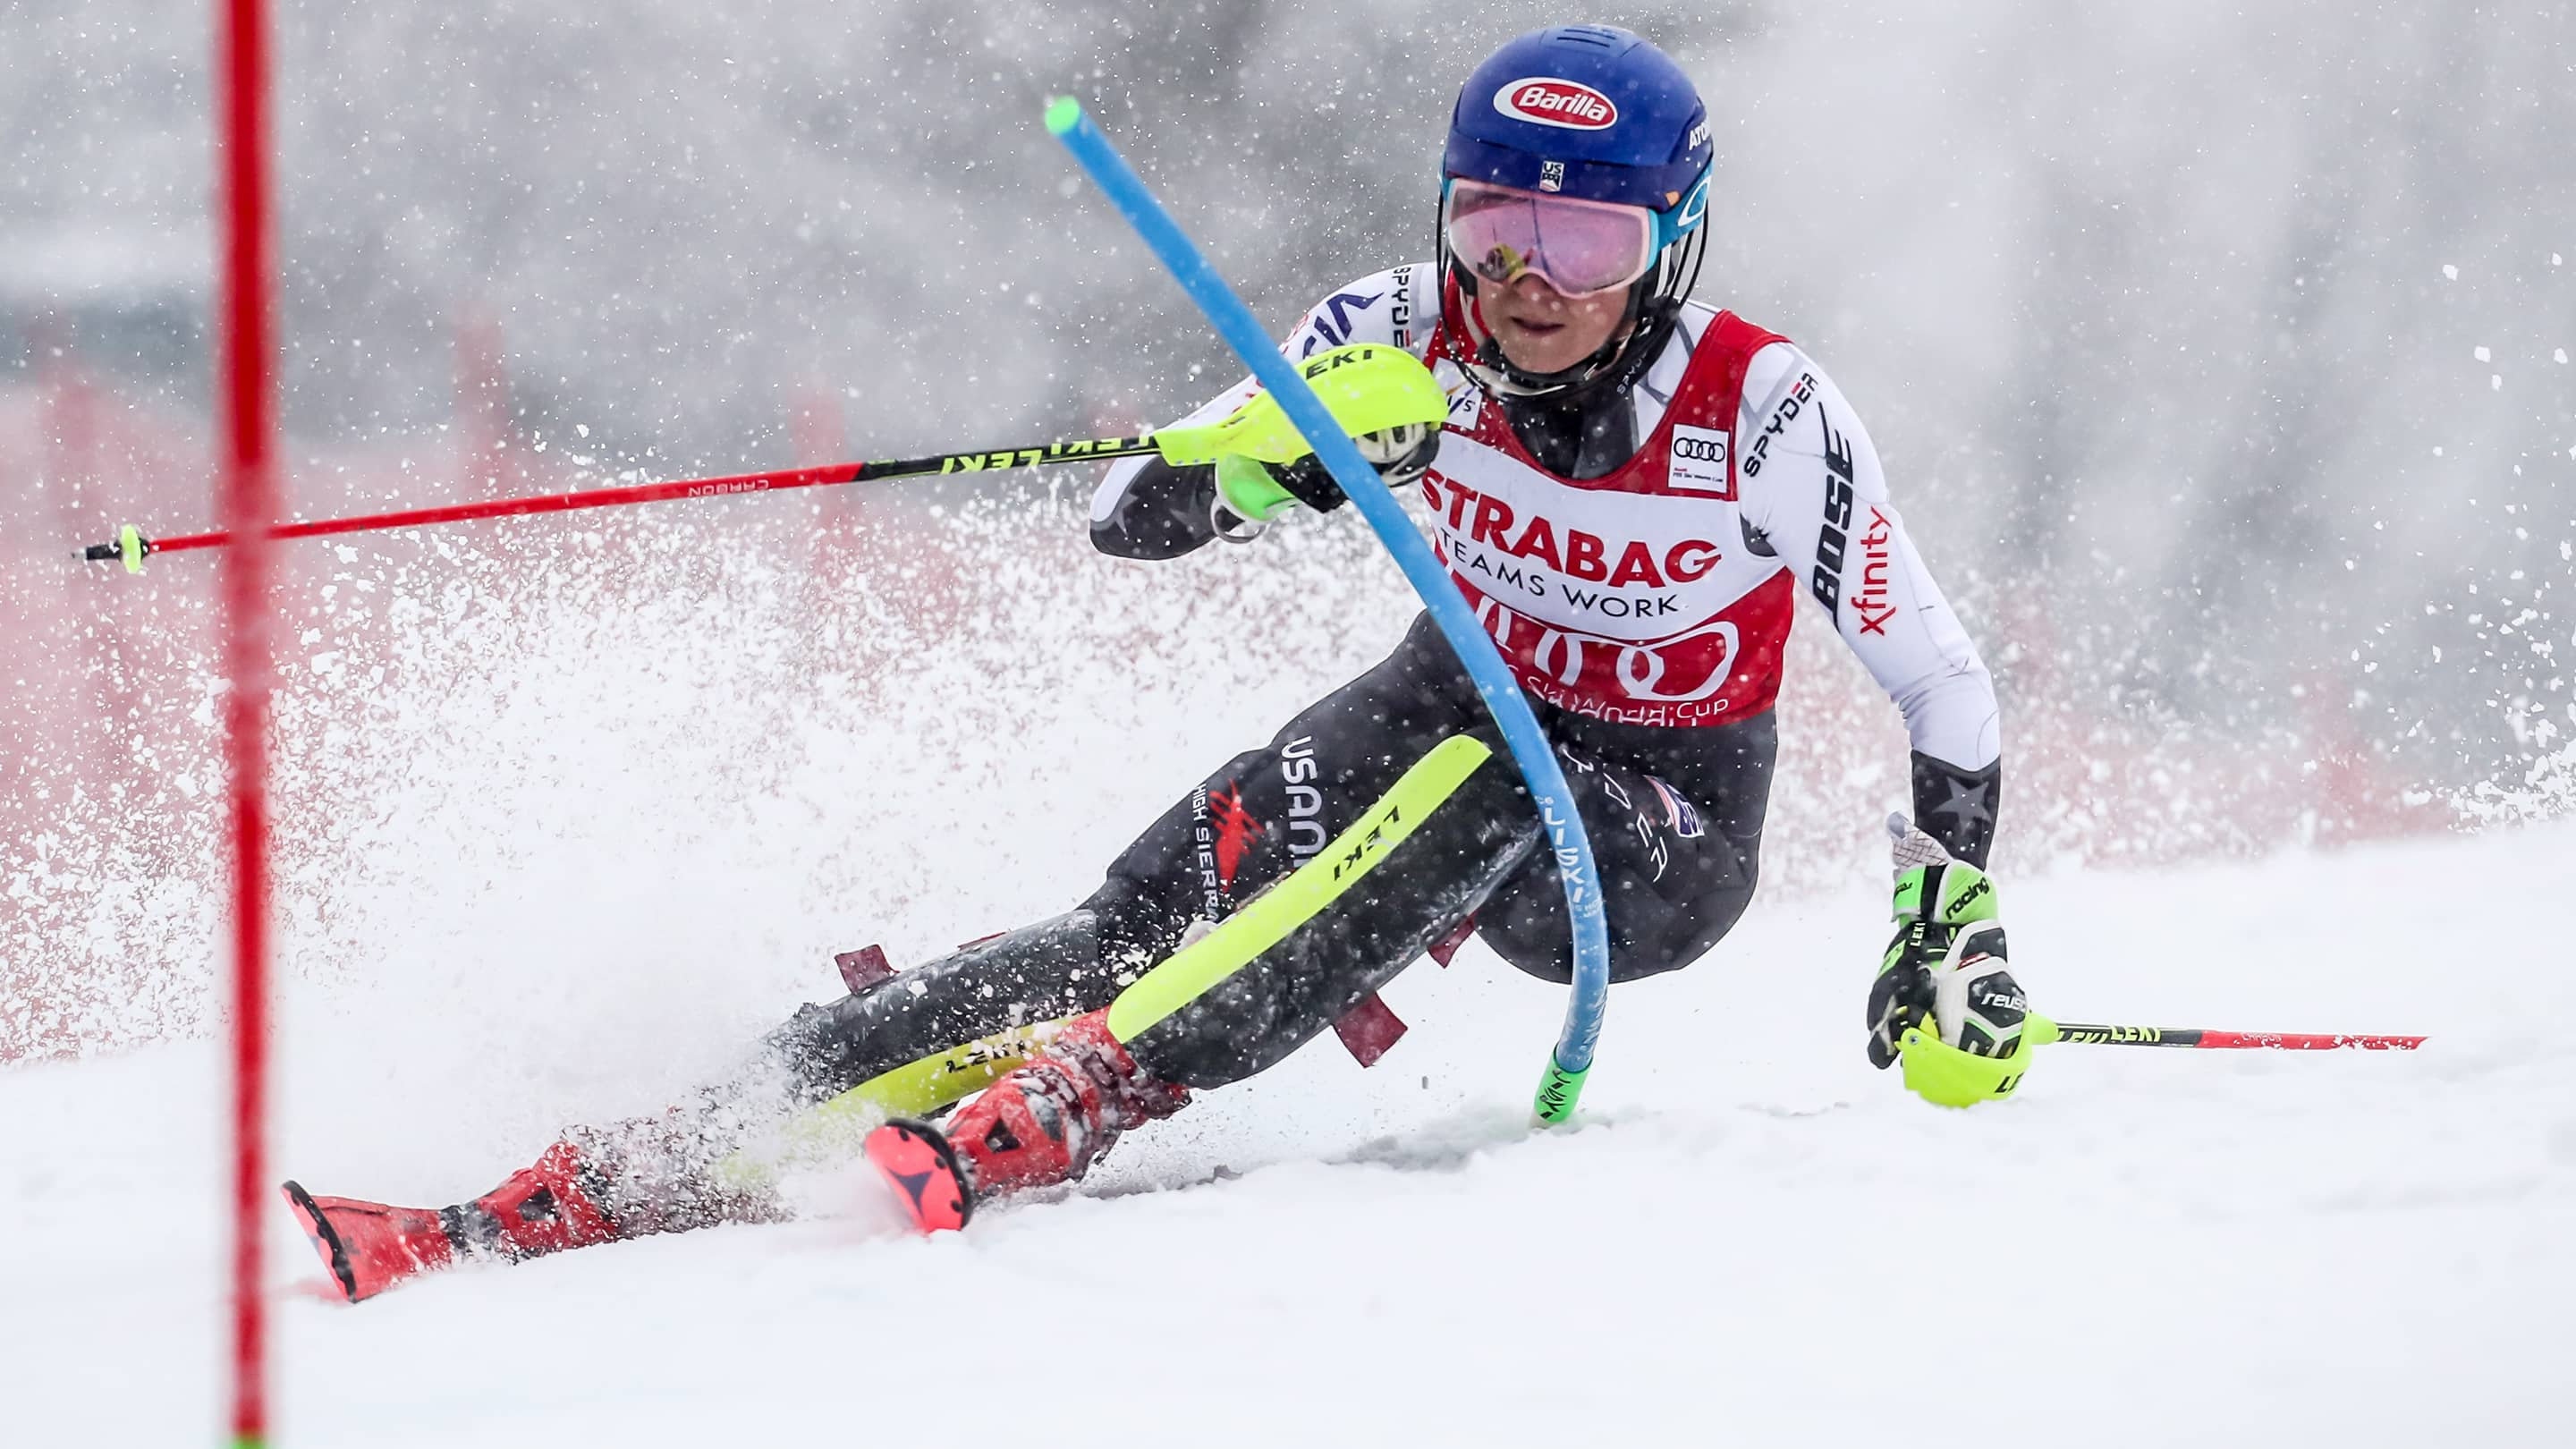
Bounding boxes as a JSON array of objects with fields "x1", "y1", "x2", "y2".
[{"x1": 1440, "y1": 178, "x2": 1662, "y2": 296}]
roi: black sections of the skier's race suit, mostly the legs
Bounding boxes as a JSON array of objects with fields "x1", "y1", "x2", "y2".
[{"x1": 747, "y1": 340, "x2": 2002, "y2": 1098}]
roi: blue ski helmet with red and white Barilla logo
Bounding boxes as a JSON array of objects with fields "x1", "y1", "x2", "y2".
[{"x1": 1440, "y1": 26, "x2": 1716, "y2": 392}]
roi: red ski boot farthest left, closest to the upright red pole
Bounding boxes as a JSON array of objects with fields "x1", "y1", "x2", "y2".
[{"x1": 281, "y1": 1142, "x2": 621, "y2": 1302}]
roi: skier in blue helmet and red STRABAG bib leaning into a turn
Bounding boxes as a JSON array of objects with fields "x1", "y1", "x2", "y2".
[{"x1": 286, "y1": 26, "x2": 2022, "y2": 1300}]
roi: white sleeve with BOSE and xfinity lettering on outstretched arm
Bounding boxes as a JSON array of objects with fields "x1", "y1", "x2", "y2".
[{"x1": 1736, "y1": 343, "x2": 2004, "y2": 771}]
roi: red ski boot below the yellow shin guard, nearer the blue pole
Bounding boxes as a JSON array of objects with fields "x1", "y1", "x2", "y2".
[{"x1": 869, "y1": 1011, "x2": 1191, "y2": 1233}]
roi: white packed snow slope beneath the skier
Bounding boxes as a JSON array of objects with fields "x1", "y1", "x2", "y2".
[{"x1": 0, "y1": 827, "x2": 2576, "y2": 1446}]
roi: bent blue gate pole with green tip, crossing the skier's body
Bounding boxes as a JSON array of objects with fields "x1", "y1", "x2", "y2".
[{"x1": 1046, "y1": 96, "x2": 1610, "y2": 1122}]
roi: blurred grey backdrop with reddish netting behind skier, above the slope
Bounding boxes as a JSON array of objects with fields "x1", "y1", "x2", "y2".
[{"x1": 0, "y1": 0, "x2": 2576, "y2": 1055}]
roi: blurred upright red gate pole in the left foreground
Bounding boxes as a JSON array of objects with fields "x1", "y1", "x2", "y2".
[{"x1": 216, "y1": 0, "x2": 278, "y2": 1449}]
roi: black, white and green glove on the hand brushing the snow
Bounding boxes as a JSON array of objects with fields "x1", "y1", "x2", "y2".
[{"x1": 1870, "y1": 815, "x2": 2029, "y2": 1072}]
